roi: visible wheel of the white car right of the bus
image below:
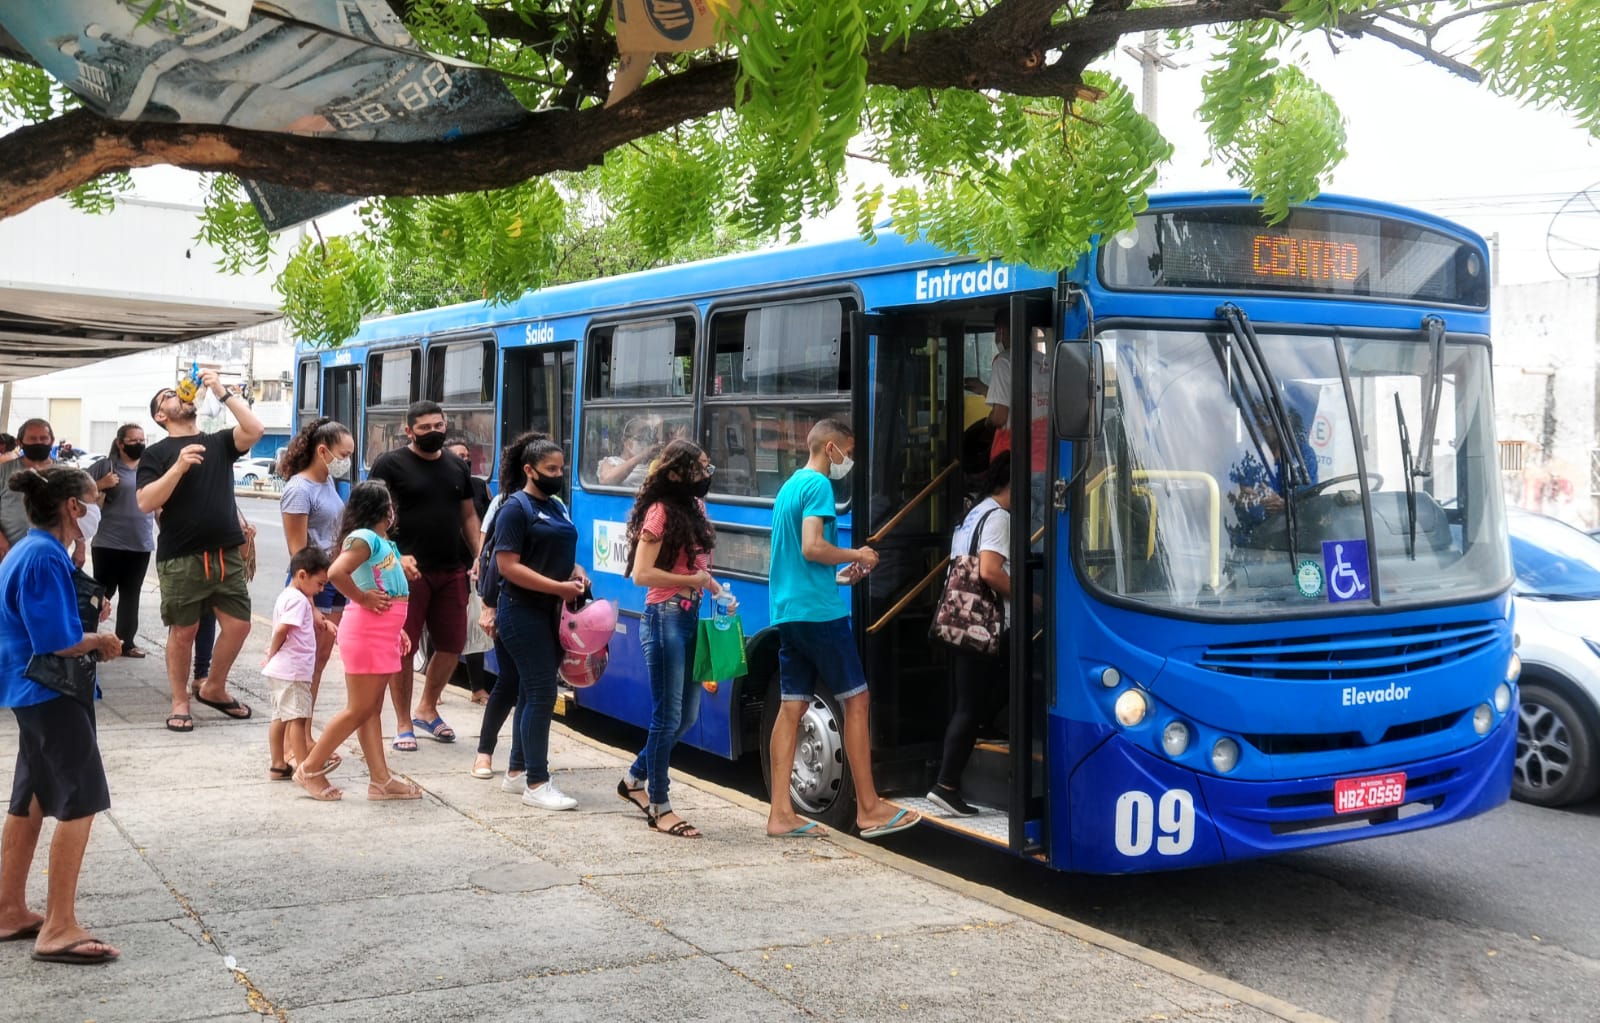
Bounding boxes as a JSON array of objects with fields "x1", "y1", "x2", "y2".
[{"x1": 1512, "y1": 684, "x2": 1600, "y2": 807}]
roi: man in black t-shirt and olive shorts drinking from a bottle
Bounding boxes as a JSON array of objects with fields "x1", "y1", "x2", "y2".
[{"x1": 138, "y1": 370, "x2": 264, "y2": 732}]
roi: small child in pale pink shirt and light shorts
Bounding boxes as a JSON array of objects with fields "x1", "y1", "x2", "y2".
[{"x1": 261, "y1": 546, "x2": 330, "y2": 781}]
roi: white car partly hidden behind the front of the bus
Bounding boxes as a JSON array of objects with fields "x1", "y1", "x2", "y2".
[{"x1": 1509, "y1": 509, "x2": 1600, "y2": 807}]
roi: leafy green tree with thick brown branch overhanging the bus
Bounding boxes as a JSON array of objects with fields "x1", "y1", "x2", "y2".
[{"x1": 0, "y1": 0, "x2": 1600, "y2": 343}]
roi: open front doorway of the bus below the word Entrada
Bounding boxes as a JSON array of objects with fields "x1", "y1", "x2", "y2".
[{"x1": 850, "y1": 298, "x2": 1050, "y2": 853}]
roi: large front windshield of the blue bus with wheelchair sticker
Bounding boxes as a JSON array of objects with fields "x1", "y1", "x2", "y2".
[{"x1": 1075, "y1": 328, "x2": 1510, "y2": 618}]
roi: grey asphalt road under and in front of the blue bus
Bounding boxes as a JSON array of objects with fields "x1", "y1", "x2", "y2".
[{"x1": 240, "y1": 498, "x2": 1600, "y2": 1023}]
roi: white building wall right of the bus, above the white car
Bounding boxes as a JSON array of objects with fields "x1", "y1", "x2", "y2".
[{"x1": 1493, "y1": 277, "x2": 1600, "y2": 528}]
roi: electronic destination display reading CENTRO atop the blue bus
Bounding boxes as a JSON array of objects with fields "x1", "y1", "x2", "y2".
[{"x1": 1101, "y1": 207, "x2": 1488, "y2": 307}]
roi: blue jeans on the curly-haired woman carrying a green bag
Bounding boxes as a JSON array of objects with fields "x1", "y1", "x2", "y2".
[{"x1": 627, "y1": 599, "x2": 701, "y2": 807}]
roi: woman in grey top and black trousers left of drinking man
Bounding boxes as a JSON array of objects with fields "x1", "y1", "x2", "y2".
[{"x1": 90, "y1": 423, "x2": 155, "y2": 658}]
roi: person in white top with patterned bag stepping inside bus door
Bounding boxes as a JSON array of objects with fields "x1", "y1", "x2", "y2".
[{"x1": 928, "y1": 451, "x2": 1011, "y2": 816}]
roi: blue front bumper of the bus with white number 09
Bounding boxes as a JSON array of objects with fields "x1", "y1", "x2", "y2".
[{"x1": 1051, "y1": 714, "x2": 1517, "y2": 874}]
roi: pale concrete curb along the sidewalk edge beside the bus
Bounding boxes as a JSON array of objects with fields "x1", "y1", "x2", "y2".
[{"x1": 552, "y1": 720, "x2": 1338, "y2": 1023}]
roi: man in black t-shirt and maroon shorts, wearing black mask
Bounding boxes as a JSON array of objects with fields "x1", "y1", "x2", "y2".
[{"x1": 371, "y1": 400, "x2": 483, "y2": 751}]
